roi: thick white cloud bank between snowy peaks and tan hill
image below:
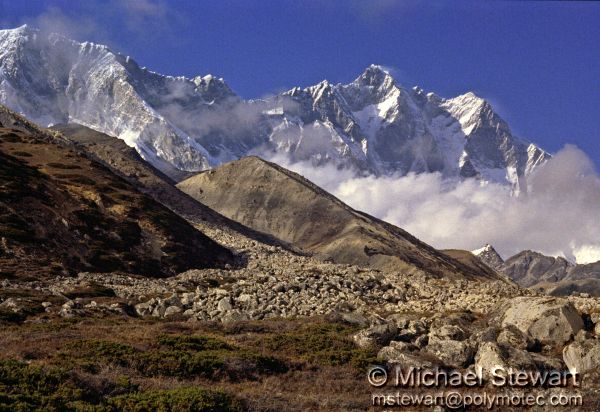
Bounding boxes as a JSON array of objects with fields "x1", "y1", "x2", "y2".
[{"x1": 272, "y1": 146, "x2": 600, "y2": 263}]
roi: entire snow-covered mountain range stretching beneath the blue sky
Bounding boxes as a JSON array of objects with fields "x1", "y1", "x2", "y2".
[{"x1": 0, "y1": 26, "x2": 549, "y2": 187}]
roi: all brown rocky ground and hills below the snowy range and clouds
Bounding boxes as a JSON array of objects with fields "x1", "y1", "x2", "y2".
[{"x1": 0, "y1": 102, "x2": 600, "y2": 411}]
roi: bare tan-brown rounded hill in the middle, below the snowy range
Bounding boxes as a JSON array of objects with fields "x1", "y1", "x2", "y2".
[{"x1": 178, "y1": 157, "x2": 510, "y2": 279}]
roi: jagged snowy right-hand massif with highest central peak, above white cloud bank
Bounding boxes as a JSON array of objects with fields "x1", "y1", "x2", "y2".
[{"x1": 271, "y1": 65, "x2": 549, "y2": 190}]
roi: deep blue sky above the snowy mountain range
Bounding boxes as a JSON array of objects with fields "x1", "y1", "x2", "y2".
[{"x1": 0, "y1": 0, "x2": 600, "y2": 166}]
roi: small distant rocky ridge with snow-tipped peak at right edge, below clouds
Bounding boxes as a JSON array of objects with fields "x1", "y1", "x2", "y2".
[{"x1": 472, "y1": 245, "x2": 600, "y2": 296}]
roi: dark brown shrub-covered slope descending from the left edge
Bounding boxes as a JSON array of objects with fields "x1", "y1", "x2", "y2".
[{"x1": 0, "y1": 108, "x2": 235, "y2": 278}]
